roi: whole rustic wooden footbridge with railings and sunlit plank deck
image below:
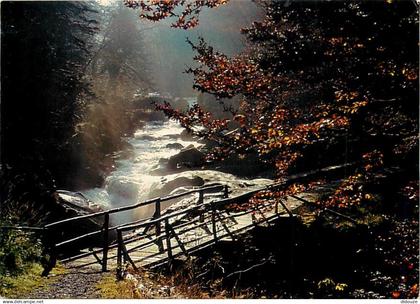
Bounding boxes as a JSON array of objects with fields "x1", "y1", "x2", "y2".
[{"x1": 1, "y1": 166, "x2": 352, "y2": 272}]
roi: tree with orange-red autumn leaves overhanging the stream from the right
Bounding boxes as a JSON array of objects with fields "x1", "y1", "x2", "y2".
[{"x1": 126, "y1": 0, "x2": 419, "y2": 211}]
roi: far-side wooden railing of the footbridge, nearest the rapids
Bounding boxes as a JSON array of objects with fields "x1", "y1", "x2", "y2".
[{"x1": 1, "y1": 163, "x2": 354, "y2": 271}]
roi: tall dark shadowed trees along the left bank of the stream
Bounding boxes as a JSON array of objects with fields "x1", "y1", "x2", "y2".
[{"x1": 1, "y1": 2, "x2": 96, "y2": 218}]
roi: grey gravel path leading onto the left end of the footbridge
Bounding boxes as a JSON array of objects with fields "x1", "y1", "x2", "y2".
[{"x1": 28, "y1": 269, "x2": 103, "y2": 299}]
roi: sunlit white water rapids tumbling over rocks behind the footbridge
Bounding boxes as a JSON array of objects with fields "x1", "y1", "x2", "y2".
[{"x1": 82, "y1": 121, "x2": 270, "y2": 223}]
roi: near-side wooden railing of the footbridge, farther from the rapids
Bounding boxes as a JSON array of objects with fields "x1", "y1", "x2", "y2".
[{"x1": 116, "y1": 183, "x2": 293, "y2": 276}]
